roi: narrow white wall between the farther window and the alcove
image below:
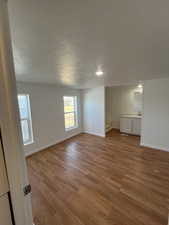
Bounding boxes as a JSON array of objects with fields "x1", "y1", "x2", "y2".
[{"x1": 82, "y1": 87, "x2": 105, "y2": 137}]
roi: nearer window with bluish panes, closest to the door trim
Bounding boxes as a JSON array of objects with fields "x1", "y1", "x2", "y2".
[{"x1": 18, "y1": 94, "x2": 33, "y2": 145}]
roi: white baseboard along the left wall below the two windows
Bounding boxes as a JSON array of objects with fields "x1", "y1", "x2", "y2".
[{"x1": 25, "y1": 132, "x2": 82, "y2": 157}]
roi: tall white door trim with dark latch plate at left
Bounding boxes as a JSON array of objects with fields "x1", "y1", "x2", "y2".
[{"x1": 0, "y1": 0, "x2": 33, "y2": 225}]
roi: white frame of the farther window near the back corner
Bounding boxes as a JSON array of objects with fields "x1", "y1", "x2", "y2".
[{"x1": 63, "y1": 95, "x2": 79, "y2": 131}]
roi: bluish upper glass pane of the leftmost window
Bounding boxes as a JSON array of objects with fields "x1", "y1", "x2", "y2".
[{"x1": 18, "y1": 95, "x2": 29, "y2": 119}]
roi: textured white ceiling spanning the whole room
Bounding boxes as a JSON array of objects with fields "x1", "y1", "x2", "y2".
[{"x1": 9, "y1": 0, "x2": 169, "y2": 88}]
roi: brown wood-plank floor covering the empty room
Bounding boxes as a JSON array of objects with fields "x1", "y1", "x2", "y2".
[{"x1": 27, "y1": 131, "x2": 169, "y2": 225}]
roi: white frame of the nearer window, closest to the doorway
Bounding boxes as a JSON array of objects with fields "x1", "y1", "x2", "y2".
[{"x1": 18, "y1": 93, "x2": 34, "y2": 146}]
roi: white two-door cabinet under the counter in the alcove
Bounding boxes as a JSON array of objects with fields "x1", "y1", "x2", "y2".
[{"x1": 120, "y1": 116, "x2": 141, "y2": 135}]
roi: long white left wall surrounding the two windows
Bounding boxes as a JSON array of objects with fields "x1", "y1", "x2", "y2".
[{"x1": 17, "y1": 83, "x2": 82, "y2": 155}]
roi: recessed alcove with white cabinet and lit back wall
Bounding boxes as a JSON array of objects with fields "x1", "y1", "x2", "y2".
[{"x1": 105, "y1": 83, "x2": 143, "y2": 136}]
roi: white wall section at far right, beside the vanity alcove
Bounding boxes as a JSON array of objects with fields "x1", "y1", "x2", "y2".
[{"x1": 141, "y1": 79, "x2": 169, "y2": 151}]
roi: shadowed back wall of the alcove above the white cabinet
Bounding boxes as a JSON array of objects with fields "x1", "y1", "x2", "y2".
[{"x1": 106, "y1": 85, "x2": 143, "y2": 129}]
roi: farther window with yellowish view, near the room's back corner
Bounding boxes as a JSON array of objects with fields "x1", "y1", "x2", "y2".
[{"x1": 63, "y1": 96, "x2": 78, "y2": 130}]
